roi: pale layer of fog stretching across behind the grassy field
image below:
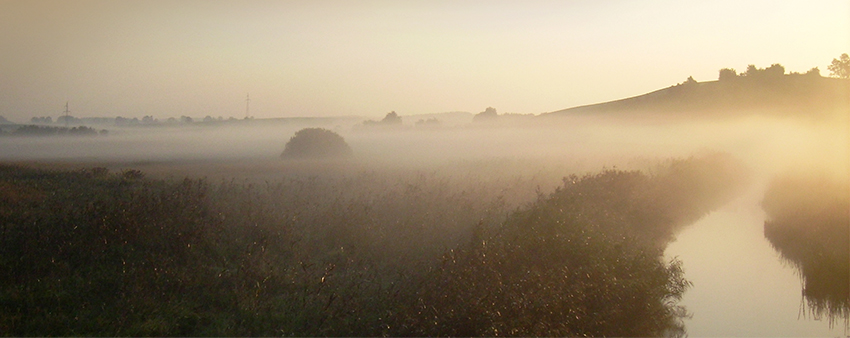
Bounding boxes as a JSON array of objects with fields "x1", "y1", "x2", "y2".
[{"x1": 0, "y1": 113, "x2": 850, "y2": 184}]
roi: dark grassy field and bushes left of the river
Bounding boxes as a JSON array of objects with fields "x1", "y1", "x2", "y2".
[{"x1": 0, "y1": 156, "x2": 742, "y2": 336}]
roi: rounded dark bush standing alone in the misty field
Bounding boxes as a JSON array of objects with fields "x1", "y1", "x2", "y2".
[{"x1": 280, "y1": 128, "x2": 352, "y2": 159}]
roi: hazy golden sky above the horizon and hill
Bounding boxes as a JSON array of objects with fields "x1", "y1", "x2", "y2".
[{"x1": 0, "y1": 0, "x2": 850, "y2": 122}]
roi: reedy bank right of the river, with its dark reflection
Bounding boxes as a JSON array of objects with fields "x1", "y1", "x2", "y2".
[{"x1": 762, "y1": 176, "x2": 850, "y2": 331}]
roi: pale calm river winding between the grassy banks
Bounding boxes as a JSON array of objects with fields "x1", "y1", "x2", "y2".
[{"x1": 665, "y1": 184, "x2": 850, "y2": 337}]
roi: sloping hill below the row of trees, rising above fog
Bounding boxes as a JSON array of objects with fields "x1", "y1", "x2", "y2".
[{"x1": 541, "y1": 74, "x2": 850, "y2": 118}]
